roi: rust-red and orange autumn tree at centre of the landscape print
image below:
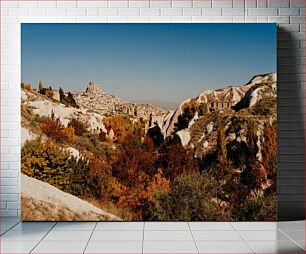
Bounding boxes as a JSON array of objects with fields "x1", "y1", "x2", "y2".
[{"x1": 113, "y1": 134, "x2": 169, "y2": 212}]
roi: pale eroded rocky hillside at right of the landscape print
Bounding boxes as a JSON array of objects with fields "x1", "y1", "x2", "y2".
[{"x1": 149, "y1": 73, "x2": 277, "y2": 160}]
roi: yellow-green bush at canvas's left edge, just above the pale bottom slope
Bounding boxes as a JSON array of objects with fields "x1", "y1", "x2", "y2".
[{"x1": 21, "y1": 138, "x2": 100, "y2": 197}]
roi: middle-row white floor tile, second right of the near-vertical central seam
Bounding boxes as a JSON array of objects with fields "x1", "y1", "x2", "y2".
[{"x1": 192, "y1": 231, "x2": 243, "y2": 241}]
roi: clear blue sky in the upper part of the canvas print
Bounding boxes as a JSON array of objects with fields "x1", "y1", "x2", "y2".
[{"x1": 21, "y1": 24, "x2": 276, "y2": 103}]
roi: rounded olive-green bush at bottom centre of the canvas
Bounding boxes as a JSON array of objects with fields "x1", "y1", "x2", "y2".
[{"x1": 148, "y1": 174, "x2": 230, "y2": 221}]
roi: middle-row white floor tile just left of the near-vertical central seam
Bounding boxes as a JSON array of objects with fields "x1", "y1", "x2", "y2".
[{"x1": 90, "y1": 231, "x2": 143, "y2": 242}]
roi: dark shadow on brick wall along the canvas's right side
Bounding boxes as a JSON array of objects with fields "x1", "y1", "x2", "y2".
[{"x1": 277, "y1": 27, "x2": 305, "y2": 221}]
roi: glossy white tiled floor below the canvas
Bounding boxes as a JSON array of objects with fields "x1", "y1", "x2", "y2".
[{"x1": 0, "y1": 218, "x2": 305, "y2": 254}]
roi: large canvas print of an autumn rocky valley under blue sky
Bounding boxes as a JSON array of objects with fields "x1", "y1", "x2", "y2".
[{"x1": 21, "y1": 23, "x2": 277, "y2": 221}]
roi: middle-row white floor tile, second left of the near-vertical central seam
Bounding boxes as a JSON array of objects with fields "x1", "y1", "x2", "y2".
[{"x1": 42, "y1": 230, "x2": 92, "y2": 242}]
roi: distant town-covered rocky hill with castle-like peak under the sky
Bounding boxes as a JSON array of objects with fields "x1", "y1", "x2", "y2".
[{"x1": 73, "y1": 82, "x2": 163, "y2": 119}]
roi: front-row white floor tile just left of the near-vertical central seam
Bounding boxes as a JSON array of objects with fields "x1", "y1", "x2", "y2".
[{"x1": 85, "y1": 242, "x2": 142, "y2": 253}]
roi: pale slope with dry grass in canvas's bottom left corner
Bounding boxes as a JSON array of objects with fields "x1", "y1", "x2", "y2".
[{"x1": 21, "y1": 174, "x2": 120, "y2": 221}]
